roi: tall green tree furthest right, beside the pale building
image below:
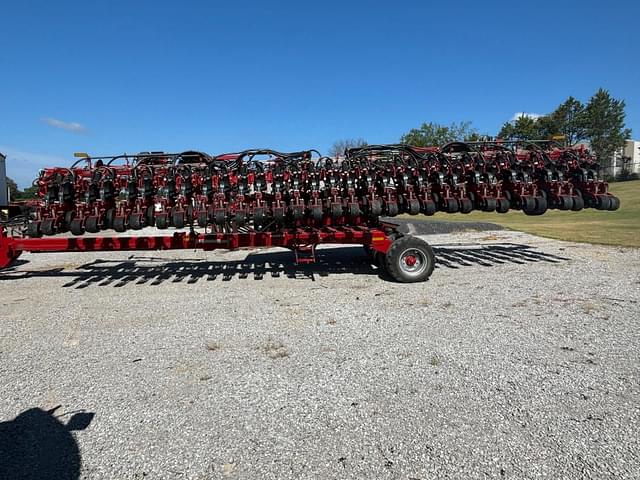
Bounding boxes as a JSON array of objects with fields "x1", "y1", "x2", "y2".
[{"x1": 584, "y1": 88, "x2": 631, "y2": 167}]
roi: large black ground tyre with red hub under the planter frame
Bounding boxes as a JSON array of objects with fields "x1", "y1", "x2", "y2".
[{"x1": 385, "y1": 236, "x2": 436, "y2": 283}]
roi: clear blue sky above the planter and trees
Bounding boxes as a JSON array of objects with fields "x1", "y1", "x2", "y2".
[{"x1": 0, "y1": 0, "x2": 640, "y2": 187}]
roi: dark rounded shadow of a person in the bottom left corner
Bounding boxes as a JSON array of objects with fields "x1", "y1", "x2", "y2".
[{"x1": 0, "y1": 407, "x2": 94, "y2": 480}]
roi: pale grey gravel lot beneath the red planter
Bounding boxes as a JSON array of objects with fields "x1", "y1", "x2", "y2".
[{"x1": 0, "y1": 231, "x2": 640, "y2": 479}]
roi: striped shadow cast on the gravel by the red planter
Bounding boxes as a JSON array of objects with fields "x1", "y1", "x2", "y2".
[{"x1": 0, "y1": 243, "x2": 568, "y2": 289}]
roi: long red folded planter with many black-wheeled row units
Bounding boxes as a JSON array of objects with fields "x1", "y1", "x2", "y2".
[{"x1": 0, "y1": 142, "x2": 620, "y2": 282}]
